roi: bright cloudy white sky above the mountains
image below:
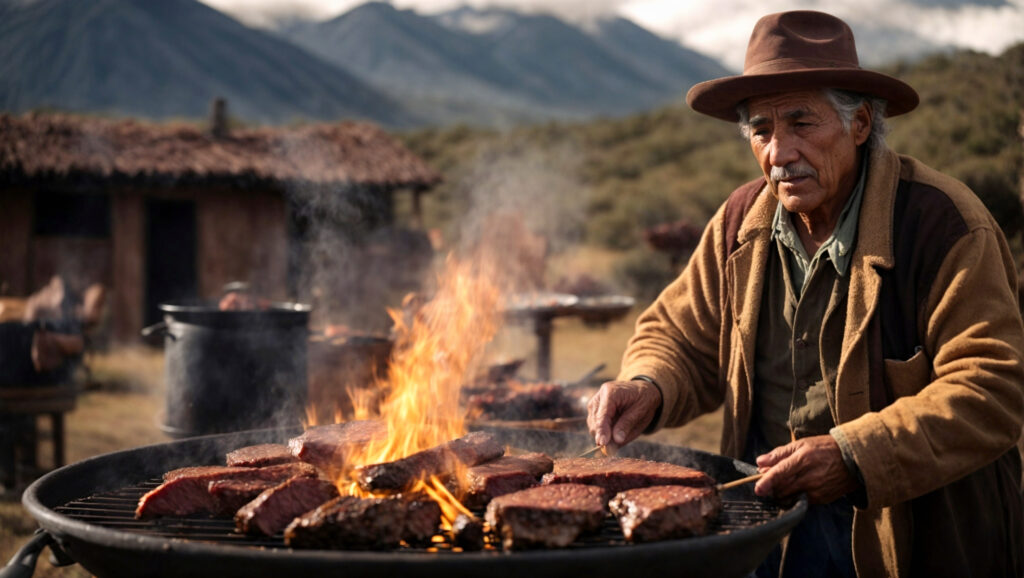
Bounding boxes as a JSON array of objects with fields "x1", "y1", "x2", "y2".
[{"x1": 202, "y1": 0, "x2": 1024, "y2": 71}]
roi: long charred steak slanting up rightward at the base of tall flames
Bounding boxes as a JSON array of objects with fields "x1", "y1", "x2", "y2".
[{"x1": 356, "y1": 431, "x2": 505, "y2": 492}]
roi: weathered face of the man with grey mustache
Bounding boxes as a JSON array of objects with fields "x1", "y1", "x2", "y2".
[{"x1": 748, "y1": 90, "x2": 870, "y2": 226}]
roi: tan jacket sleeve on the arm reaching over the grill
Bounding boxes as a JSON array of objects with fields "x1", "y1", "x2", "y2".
[{"x1": 618, "y1": 201, "x2": 725, "y2": 430}]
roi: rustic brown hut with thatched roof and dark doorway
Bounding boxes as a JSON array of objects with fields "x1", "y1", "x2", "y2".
[{"x1": 0, "y1": 113, "x2": 440, "y2": 339}]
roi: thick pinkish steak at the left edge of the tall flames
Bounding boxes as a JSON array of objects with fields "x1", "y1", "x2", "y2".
[{"x1": 288, "y1": 419, "x2": 387, "y2": 479}]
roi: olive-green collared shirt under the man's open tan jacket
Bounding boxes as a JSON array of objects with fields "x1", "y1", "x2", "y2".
[{"x1": 754, "y1": 154, "x2": 866, "y2": 457}]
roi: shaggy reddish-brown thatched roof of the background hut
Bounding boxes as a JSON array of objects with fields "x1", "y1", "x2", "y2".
[{"x1": 0, "y1": 113, "x2": 440, "y2": 189}]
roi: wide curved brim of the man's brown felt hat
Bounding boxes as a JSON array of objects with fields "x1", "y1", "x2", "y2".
[{"x1": 686, "y1": 69, "x2": 920, "y2": 122}]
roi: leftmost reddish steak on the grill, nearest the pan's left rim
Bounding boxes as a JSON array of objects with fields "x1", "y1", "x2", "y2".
[{"x1": 135, "y1": 462, "x2": 318, "y2": 519}]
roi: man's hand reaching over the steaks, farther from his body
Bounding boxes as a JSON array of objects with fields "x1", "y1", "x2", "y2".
[{"x1": 587, "y1": 379, "x2": 662, "y2": 449}]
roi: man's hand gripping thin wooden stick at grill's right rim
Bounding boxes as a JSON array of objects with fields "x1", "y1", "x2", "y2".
[{"x1": 754, "y1": 436, "x2": 859, "y2": 504}]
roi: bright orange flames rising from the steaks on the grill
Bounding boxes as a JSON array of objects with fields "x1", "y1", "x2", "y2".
[{"x1": 307, "y1": 256, "x2": 501, "y2": 524}]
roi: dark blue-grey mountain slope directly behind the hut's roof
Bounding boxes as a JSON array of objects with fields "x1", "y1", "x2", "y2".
[{"x1": 0, "y1": 0, "x2": 415, "y2": 126}]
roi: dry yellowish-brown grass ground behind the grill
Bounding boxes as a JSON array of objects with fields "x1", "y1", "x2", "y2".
[{"x1": 0, "y1": 316, "x2": 720, "y2": 577}]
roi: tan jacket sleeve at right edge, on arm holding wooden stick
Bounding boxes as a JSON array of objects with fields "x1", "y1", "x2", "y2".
[{"x1": 840, "y1": 223, "x2": 1024, "y2": 507}]
